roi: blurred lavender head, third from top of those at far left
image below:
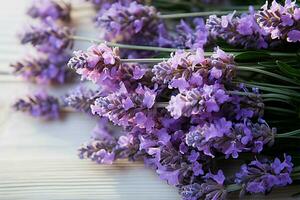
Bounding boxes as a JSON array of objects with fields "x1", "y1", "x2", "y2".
[{"x1": 11, "y1": 54, "x2": 70, "y2": 84}]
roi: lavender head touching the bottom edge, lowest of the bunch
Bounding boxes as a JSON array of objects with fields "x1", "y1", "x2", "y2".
[{"x1": 180, "y1": 170, "x2": 227, "y2": 200}]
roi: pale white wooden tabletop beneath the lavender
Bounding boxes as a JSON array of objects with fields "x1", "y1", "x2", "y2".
[{"x1": 0, "y1": 0, "x2": 300, "y2": 200}]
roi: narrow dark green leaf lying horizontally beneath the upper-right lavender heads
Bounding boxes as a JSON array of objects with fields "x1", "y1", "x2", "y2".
[{"x1": 235, "y1": 51, "x2": 271, "y2": 62}]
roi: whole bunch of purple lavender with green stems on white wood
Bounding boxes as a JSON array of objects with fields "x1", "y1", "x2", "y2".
[{"x1": 13, "y1": 0, "x2": 300, "y2": 200}]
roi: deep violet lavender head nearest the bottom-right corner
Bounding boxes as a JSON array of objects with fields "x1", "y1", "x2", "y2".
[{"x1": 235, "y1": 155, "x2": 293, "y2": 193}]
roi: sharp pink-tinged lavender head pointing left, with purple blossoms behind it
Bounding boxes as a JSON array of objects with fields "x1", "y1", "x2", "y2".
[{"x1": 68, "y1": 44, "x2": 147, "y2": 90}]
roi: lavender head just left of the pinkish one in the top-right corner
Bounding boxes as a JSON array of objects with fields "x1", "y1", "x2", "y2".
[{"x1": 206, "y1": 10, "x2": 268, "y2": 49}]
